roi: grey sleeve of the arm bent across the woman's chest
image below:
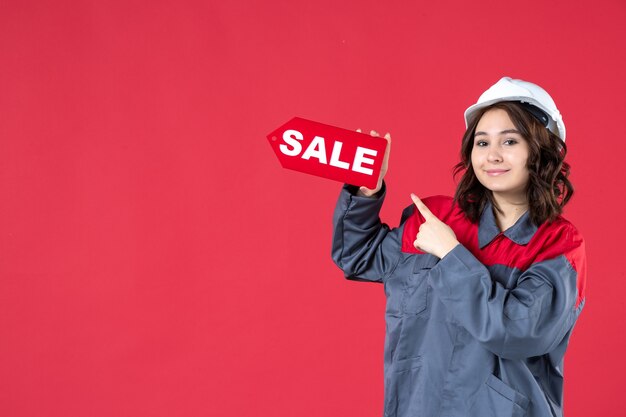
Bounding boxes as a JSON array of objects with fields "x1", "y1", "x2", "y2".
[{"x1": 429, "y1": 242, "x2": 585, "y2": 359}]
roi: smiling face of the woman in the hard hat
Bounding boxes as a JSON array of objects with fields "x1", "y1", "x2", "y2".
[{"x1": 472, "y1": 109, "x2": 529, "y2": 202}]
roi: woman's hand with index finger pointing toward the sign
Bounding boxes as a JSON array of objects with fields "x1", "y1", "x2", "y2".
[{"x1": 411, "y1": 194, "x2": 459, "y2": 259}]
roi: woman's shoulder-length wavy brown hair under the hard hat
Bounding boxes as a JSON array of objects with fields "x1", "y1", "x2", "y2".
[{"x1": 454, "y1": 101, "x2": 574, "y2": 226}]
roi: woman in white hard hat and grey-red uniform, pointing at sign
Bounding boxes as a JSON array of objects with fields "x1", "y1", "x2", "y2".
[{"x1": 332, "y1": 77, "x2": 585, "y2": 417}]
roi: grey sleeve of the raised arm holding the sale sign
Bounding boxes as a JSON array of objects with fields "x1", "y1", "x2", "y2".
[{"x1": 332, "y1": 183, "x2": 402, "y2": 282}]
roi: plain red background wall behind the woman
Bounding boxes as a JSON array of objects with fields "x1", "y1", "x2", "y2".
[{"x1": 0, "y1": 0, "x2": 626, "y2": 417}]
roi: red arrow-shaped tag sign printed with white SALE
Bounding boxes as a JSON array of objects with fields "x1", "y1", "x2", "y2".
[{"x1": 267, "y1": 117, "x2": 387, "y2": 188}]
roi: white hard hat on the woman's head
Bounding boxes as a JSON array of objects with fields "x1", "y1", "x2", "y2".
[{"x1": 465, "y1": 77, "x2": 565, "y2": 142}]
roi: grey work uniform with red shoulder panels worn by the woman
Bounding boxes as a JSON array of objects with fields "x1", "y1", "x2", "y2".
[{"x1": 332, "y1": 185, "x2": 586, "y2": 417}]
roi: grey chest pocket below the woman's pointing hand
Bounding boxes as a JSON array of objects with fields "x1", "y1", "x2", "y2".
[{"x1": 401, "y1": 254, "x2": 439, "y2": 314}]
